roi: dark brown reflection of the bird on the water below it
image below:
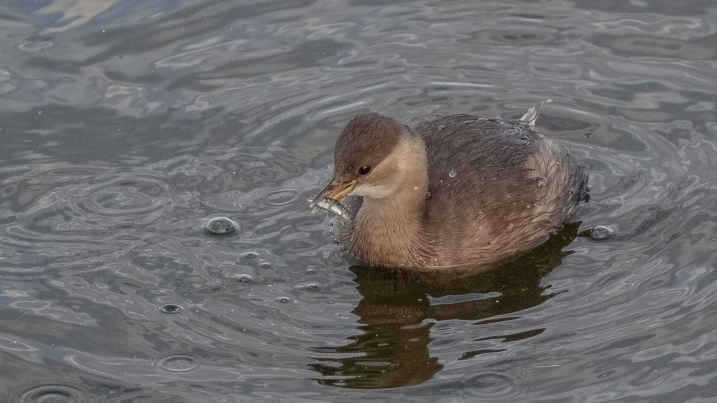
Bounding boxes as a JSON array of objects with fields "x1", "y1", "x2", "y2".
[{"x1": 309, "y1": 223, "x2": 580, "y2": 389}]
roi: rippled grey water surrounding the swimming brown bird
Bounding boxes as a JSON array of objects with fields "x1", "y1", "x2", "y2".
[{"x1": 0, "y1": 0, "x2": 717, "y2": 402}]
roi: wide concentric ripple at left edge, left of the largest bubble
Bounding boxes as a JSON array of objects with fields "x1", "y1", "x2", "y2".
[{"x1": 0, "y1": 164, "x2": 192, "y2": 271}]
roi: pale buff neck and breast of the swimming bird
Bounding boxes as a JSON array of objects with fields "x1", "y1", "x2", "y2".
[{"x1": 353, "y1": 138, "x2": 428, "y2": 267}]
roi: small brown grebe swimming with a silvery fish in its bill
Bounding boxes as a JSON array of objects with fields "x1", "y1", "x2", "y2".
[{"x1": 310, "y1": 105, "x2": 588, "y2": 269}]
